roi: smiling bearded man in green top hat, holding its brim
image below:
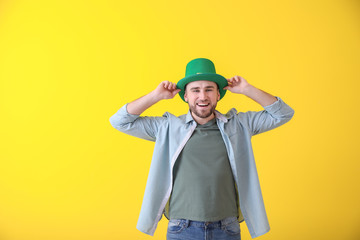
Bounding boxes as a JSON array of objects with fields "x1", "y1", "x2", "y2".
[{"x1": 110, "y1": 58, "x2": 294, "y2": 240}]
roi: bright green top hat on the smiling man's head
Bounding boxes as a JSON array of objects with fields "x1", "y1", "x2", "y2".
[{"x1": 176, "y1": 58, "x2": 228, "y2": 102}]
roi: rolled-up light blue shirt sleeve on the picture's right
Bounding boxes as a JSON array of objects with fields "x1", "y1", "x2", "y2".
[{"x1": 238, "y1": 97, "x2": 294, "y2": 135}]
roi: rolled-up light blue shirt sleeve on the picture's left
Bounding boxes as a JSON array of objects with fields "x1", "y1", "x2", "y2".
[{"x1": 110, "y1": 104, "x2": 166, "y2": 141}]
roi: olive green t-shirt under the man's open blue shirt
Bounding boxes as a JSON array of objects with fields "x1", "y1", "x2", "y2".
[{"x1": 165, "y1": 118, "x2": 238, "y2": 221}]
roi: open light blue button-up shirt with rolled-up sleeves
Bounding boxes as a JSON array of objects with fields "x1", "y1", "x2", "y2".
[{"x1": 110, "y1": 97, "x2": 294, "y2": 238}]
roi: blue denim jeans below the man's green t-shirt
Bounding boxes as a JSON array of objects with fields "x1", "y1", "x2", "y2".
[{"x1": 166, "y1": 217, "x2": 241, "y2": 240}]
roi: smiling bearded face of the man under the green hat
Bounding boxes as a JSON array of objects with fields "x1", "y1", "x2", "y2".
[{"x1": 184, "y1": 80, "x2": 220, "y2": 123}]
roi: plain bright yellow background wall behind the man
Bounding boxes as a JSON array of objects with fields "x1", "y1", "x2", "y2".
[{"x1": 0, "y1": 0, "x2": 360, "y2": 240}]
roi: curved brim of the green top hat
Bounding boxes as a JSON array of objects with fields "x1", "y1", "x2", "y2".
[{"x1": 176, "y1": 73, "x2": 228, "y2": 102}]
